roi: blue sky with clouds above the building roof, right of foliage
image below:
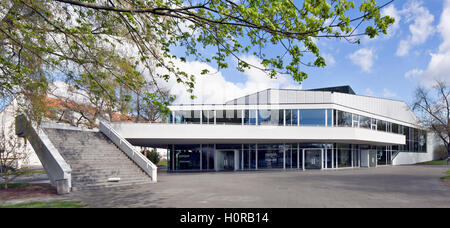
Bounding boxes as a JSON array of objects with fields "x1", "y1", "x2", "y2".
[{"x1": 165, "y1": 0, "x2": 450, "y2": 104}]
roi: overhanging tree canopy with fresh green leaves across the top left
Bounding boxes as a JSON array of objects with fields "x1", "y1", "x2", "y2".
[{"x1": 0, "y1": 0, "x2": 394, "y2": 117}]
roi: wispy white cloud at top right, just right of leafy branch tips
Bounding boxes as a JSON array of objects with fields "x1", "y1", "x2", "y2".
[{"x1": 394, "y1": 1, "x2": 435, "y2": 56}]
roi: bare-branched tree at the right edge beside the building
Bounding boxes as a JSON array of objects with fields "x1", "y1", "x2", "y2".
[{"x1": 413, "y1": 81, "x2": 450, "y2": 161}]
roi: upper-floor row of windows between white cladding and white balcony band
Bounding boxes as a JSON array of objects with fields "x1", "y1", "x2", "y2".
[{"x1": 169, "y1": 109, "x2": 426, "y2": 152}]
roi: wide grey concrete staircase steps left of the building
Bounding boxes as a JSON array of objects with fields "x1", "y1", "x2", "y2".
[{"x1": 44, "y1": 128, "x2": 151, "y2": 191}]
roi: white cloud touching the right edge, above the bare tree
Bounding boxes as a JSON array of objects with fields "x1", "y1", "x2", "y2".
[{"x1": 405, "y1": 0, "x2": 450, "y2": 87}]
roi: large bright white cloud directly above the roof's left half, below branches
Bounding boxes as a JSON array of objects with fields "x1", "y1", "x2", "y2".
[{"x1": 161, "y1": 56, "x2": 301, "y2": 104}]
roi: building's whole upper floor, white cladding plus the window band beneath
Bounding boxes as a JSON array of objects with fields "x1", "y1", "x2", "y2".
[{"x1": 168, "y1": 87, "x2": 426, "y2": 151}]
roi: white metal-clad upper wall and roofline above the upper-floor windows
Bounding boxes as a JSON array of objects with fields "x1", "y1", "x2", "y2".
[{"x1": 169, "y1": 86, "x2": 420, "y2": 128}]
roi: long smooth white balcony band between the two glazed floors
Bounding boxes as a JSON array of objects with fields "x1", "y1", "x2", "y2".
[{"x1": 111, "y1": 123, "x2": 405, "y2": 145}]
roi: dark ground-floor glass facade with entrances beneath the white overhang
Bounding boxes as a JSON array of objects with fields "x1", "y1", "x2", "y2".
[{"x1": 168, "y1": 143, "x2": 396, "y2": 171}]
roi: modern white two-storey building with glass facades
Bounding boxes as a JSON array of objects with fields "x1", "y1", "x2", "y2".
[{"x1": 106, "y1": 86, "x2": 433, "y2": 171}]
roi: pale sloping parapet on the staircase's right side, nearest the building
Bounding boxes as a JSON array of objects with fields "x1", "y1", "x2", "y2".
[{"x1": 99, "y1": 121, "x2": 158, "y2": 182}]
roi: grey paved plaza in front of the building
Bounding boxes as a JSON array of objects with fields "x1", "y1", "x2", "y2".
[{"x1": 59, "y1": 165, "x2": 450, "y2": 208}]
